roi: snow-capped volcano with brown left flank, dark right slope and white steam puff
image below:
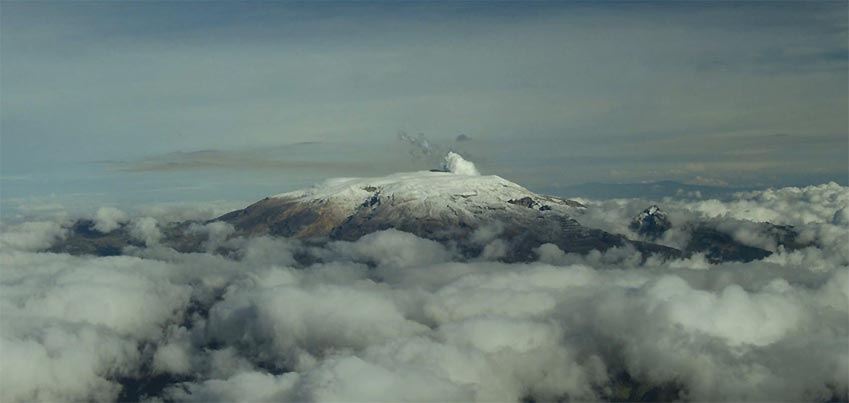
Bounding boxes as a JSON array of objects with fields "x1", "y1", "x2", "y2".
[{"x1": 218, "y1": 153, "x2": 677, "y2": 260}]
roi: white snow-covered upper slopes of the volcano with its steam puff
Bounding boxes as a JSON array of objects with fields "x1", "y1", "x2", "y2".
[{"x1": 272, "y1": 152, "x2": 580, "y2": 227}]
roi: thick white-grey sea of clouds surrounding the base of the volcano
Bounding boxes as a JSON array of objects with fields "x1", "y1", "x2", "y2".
[{"x1": 0, "y1": 184, "x2": 849, "y2": 402}]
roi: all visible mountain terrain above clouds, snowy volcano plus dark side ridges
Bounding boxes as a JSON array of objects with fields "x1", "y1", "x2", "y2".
[{"x1": 50, "y1": 158, "x2": 796, "y2": 262}]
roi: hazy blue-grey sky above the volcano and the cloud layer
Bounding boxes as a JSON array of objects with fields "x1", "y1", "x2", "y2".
[{"x1": 0, "y1": 1, "x2": 849, "y2": 211}]
